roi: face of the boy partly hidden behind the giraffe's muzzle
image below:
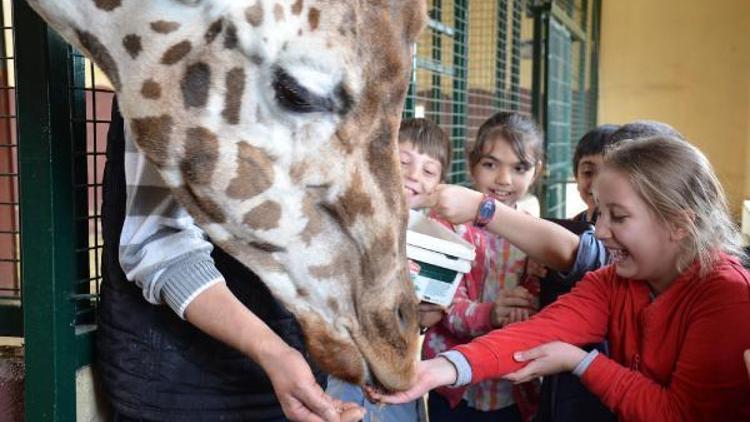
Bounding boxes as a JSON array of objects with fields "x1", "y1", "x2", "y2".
[{"x1": 398, "y1": 142, "x2": 443, "y2": 208}]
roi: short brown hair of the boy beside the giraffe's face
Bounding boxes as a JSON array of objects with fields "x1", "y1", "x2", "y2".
[{"x1": 398, "y1": 118, "x2": 453, "y2": 181}]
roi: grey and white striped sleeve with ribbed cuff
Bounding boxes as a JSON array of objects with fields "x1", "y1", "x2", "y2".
[{"x1": 119, "y1": 129, "x2": 224, "y2": 318}]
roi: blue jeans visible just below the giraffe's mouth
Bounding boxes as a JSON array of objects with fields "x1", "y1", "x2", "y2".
[{"x1": 326, "y1": 376, "x2": 425, "y2": 422}]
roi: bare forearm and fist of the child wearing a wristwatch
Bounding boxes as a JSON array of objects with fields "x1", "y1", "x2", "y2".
[{"x1": 430, "y1": 185, "x2": 579, "y2": 271}]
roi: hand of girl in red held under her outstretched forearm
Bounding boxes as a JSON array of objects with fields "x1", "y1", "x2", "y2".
[{"x1": 503, "y1": 341, "x2": 586, "y2": 383}]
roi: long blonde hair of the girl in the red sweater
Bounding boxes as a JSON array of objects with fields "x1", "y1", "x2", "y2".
[{"x1": 604, "y1": 136, "x2": 744, "y2": 276}]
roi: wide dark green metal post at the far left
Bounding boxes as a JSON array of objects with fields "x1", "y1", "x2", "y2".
[{"x1": 13, "y1": 0, "x2": 77, "y2": 422}]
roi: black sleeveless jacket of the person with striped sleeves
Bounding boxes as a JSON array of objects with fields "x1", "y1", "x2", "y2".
[{"x1": 96, "y1": 102, "x2": 325, "y2": 421}]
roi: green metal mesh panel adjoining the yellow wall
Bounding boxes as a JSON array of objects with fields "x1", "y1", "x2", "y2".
[{"x1": 530, "y1": 0, "x2": 601, "y2": 218}]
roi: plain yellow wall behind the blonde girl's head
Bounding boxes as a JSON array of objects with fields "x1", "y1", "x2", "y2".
[{"x1": 599, "y1": 0, "x2": 750, "y2": 215}]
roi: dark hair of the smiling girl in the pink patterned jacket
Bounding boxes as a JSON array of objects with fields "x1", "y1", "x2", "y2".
[{"x1": 467, "y1": 111, "x2": 544, "y2": 169}]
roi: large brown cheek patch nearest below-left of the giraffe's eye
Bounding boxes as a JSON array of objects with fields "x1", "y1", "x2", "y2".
[{"x1": 227, "y1": 142, "x2": 274, "y2": 199}]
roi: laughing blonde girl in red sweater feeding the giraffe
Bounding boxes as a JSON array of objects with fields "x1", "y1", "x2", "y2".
[{"x1": 373, "y1": 137, "x2": 750, "y2": 421}]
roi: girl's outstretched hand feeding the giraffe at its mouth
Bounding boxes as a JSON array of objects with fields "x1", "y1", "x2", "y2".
[{"x1": 364, "y1": 357, "x2": 458, "y2": 404}]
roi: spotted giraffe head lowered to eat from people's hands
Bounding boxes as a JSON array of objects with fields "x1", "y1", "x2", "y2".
[{"x1": 30, "y1": 0, "x2": 425, "y2": 389}]
